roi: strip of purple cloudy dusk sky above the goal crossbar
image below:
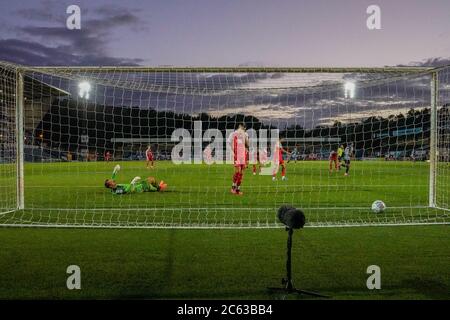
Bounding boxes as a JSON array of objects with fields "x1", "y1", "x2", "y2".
[{"x1": 0, "y1": 0, "x2": 450, "y2": 66}]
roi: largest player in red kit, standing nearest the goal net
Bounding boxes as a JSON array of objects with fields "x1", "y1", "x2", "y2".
[{"x1": 228, "y1": 124, "x2": 248, "y2": 195}]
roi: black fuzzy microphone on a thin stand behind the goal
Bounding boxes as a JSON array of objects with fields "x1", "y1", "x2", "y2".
[{"x1": 269, "y1": 206, "x2": 328, "y2": 298}]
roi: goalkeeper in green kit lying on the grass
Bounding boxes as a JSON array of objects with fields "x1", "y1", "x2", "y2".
[{"x1": 105, "y1": 165, "x2": 167, "y2": 195}]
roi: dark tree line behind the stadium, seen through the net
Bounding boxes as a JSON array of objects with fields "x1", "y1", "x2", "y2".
[{"x1": 26, "y1": 99, "x2": 450, "y2": 160}]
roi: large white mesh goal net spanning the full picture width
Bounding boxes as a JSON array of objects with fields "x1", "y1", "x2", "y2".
[{"x1": 0, "y1": 63, "x2": 450, "y2": 228}]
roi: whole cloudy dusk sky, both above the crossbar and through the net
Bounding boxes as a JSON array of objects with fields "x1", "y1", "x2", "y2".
[{"x1": 0, "y1": 0, "x2": 450, "y2": 127}]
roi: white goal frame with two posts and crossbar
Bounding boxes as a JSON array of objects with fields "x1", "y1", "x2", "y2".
[{"x1": 6, "y1": 61, "x2": 448, "y2": 227}]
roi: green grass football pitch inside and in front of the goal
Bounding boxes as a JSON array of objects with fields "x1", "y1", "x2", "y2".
[{"x1": 0, "y1": 161, "x2": 450, "y2": 299}]
